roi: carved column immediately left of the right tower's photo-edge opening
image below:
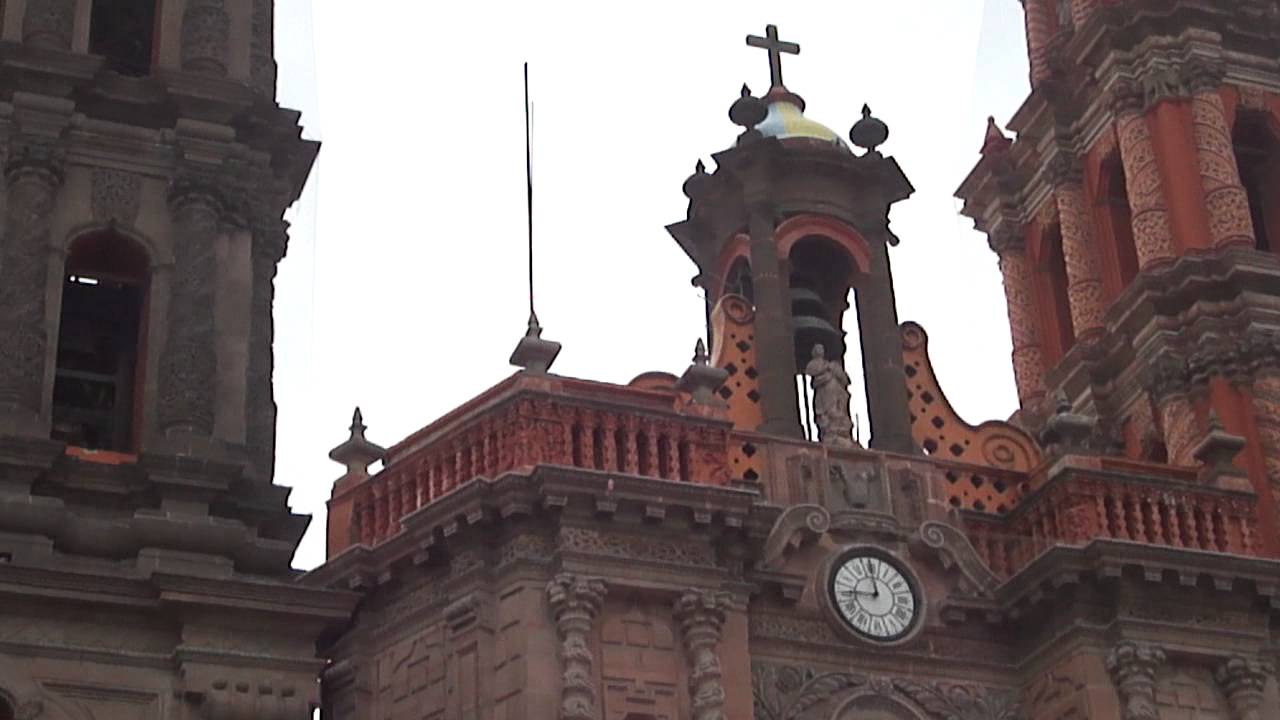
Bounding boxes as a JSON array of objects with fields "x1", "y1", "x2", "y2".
[{"x1": 1185, "y1": 61, "x2": 1254, "y2": 247}]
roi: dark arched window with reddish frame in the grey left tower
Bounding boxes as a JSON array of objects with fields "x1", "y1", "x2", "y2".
[{"x1": 52, "y1": 231, "x2": 148, "y2": 452}]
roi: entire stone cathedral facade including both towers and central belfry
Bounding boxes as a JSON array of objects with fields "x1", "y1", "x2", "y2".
[{"x1": 0, "y1": 0, "x2": 1280, "y2": 720}]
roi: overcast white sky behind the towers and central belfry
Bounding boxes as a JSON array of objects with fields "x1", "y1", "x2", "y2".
[{"x1": 275, "y1": 0, "x2": 1028, "y2": 568}]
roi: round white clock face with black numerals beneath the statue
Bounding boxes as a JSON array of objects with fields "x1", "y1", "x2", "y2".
[{"x1": 831, "y1": 553, "x2": 919, "y2": 642}]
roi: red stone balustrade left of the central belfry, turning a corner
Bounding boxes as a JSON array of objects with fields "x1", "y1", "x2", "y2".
[{"x1": 343, "y1": 375, "x2": 731, "y2": 546}]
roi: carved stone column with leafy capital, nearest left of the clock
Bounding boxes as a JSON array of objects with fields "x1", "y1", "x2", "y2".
[{"x1": 675, "y1": 591, "x2": 732, "y2": 720}]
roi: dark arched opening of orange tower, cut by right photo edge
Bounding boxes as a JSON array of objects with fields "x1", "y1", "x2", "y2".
[{"x1": 1231, "y1": 113, "x2": 1280, "y2": 252}]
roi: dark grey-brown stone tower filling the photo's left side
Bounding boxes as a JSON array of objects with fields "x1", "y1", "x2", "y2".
[{"x1": 0, "y1": 0, "x2": 349, "y2": 719}]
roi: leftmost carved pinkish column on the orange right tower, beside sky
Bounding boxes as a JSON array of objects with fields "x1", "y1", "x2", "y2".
[{"x1": 988, "y1": 231, "x2": 1044, "y2": 407}]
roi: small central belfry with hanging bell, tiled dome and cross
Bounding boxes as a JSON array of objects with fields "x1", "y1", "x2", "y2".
[{"x1": 667, "y1": 26, "x2": 914, "y2": 452}]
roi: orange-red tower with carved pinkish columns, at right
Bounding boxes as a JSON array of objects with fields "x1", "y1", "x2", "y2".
[{"x1": 959, "y1": 0, "x2": 1280, "y2": 545}]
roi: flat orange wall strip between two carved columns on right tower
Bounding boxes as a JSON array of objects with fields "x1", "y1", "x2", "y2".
[{"x1": 1147, "y1": 100, "x2": 1212, "y2": 255}]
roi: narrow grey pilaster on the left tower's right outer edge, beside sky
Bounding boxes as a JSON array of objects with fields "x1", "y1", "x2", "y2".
[{"x1": 244, "y1": 217, "x2": 289, "y2": 479}]
